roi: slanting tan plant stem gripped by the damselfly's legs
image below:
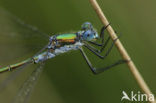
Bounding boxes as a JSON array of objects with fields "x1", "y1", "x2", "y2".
[{"x1": 89, "y1": 0, "x2": 156, "y2": 103}]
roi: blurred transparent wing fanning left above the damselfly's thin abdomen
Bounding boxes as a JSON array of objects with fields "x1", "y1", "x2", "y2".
[{"x1": 0, "y1": 8, "x2": 49, "y2": 67}]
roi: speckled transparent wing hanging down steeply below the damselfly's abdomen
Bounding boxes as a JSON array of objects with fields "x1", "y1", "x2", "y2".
[{"x1": 13, "y1": 63, "x2": 44, "y2": 103}]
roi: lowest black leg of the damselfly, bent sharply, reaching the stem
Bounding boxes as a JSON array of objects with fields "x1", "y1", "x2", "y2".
[{"x1": 80, "y1": 48, "x2": 126, "y2": 74}]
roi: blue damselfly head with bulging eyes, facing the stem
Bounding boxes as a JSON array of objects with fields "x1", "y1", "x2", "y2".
[{"x1": 82, "y1": 22, "x2": 98, "y2": 41}]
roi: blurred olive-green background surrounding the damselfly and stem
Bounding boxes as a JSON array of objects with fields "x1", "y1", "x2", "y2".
[{"x1": 0, "y1": 0, "x2": 156, "y2": 103}]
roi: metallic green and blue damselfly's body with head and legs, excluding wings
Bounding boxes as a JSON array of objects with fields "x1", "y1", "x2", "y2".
[{"x1": 0, "y1": 22, "x2": 125, "y2": 74}]
